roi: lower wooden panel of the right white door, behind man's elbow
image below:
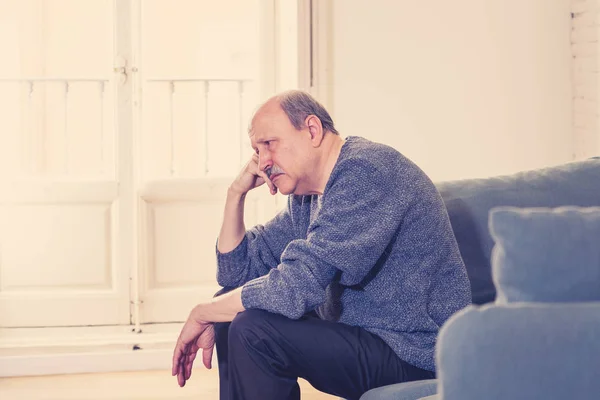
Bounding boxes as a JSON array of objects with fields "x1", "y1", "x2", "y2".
[{"x1": 140, "y1": 179, "x2": 284, "y2": 323}]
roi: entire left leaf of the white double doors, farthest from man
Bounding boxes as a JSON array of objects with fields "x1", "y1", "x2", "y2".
[{"x1": 0, "y1": 0, "x2": 134, "y2": 327}]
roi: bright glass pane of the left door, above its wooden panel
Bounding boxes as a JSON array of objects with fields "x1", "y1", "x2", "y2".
[{"x1": 0, "y1": 0, "x2": 115, "y2": 177}]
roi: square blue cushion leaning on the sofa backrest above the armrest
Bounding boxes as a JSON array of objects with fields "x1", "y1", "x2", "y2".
[{"x1": 489, "y1": 206, "x2": 600, "y2": 303}]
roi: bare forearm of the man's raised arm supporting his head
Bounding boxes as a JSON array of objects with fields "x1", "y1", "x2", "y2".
[{"x1": 217, "y1": 189, "x2": 246, "y2": 253}]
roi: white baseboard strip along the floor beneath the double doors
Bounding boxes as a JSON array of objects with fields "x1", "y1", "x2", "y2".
[{"x1": 0, "y1": 324, "x2": 188, "y2": 377}]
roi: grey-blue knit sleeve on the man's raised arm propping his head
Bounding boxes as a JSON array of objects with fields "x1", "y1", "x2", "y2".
[{"x1": 216, "y1": 196, "x2": 294, "y2": 287}]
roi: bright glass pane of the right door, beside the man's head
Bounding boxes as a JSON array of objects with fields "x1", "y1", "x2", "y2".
[{"x1": 140, "y1": 0, "x2": 264, "y2": 179}]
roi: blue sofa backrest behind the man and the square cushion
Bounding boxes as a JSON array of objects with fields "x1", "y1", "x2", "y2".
[{"x1": 436, "y1": 158, "x2": 600, "y2": 304}]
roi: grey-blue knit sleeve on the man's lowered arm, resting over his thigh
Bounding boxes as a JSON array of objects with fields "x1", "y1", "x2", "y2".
[{"x1": 242, "y1": 160, "x2": 412, "y2": 319}]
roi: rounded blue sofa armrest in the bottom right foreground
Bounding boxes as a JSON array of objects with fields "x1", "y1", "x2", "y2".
[{"x1": 437, "y1": 302, "x2": 600, "y2": 400}]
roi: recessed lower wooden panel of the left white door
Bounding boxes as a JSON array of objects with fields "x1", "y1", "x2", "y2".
[{"x1": 0, "y1": 203, "x2": 112, "y2": 291}]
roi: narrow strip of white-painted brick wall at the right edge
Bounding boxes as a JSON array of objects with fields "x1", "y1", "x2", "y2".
[{"x1": 571, "y1": 0, "x2": 600, "y2": 159}]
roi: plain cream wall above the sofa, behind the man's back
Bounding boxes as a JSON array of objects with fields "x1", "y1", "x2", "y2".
[{"x1": 332, "y1": 0, "x2": 574, "y2": 181}]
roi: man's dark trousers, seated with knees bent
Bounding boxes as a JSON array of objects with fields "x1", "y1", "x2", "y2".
[{"x1": 215, "y1": 289, "x2": 435, "y2": 400}]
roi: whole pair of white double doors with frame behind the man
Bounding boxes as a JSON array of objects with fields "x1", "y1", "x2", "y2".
[{"x1": 0, "y1": 0, "x2": 298, "y2": 327}]
